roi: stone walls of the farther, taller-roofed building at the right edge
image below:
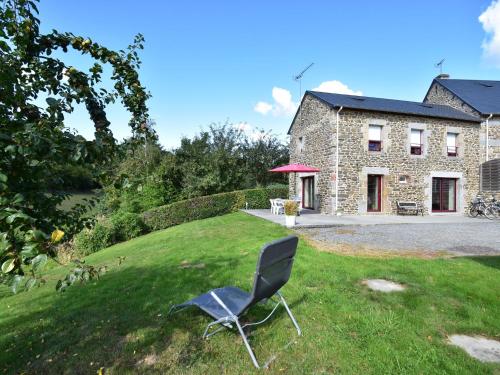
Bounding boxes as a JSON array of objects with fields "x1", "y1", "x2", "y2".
[{"x1": 424, "y1": 81, "x2": 500, "y2": 162}]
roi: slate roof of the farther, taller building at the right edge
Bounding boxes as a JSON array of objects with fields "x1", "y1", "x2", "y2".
[{"x1": 431, "y1": 78, "x2": 500, "y2": 115}]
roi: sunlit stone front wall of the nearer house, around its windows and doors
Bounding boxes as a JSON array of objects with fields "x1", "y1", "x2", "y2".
[{"x1": 339, "y1": 109, "x2": 479, "y2": 213}]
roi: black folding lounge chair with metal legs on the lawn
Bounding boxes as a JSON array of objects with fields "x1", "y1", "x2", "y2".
[{"x1": 169, "y1": 236, "x2": 301, "y2": 368}]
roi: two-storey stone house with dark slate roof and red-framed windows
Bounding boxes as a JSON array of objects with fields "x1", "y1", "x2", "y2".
[{"x1": 288, "y1": 77, "x2": 500, "y2": 215}]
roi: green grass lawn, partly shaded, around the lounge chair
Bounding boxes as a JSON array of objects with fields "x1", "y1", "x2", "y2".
[{"x1": 0, "y1": 213, "x2": 500, "y2": 374}]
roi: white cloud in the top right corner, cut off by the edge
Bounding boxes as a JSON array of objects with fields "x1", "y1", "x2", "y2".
[{"x1": 479, "y1": 0, "x2": 500, "y2": 68}]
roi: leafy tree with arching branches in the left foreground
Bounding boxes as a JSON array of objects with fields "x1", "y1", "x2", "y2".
[{"x1": 0, "y1": 0, "x2": 154, "y2": 291}]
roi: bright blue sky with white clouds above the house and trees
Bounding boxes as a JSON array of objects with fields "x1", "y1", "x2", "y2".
[{"x1": 39, "y1": 0, "x2": 500, "y2": 149}]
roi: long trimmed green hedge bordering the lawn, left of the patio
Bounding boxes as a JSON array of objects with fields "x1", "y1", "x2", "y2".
[{"x1": 143, "y1": 187, "x2": 288, "y2": 230}]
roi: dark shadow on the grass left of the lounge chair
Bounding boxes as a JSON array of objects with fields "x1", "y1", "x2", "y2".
[{"x1": 0, "y1": 257, "x2": 244, "y2": 374}]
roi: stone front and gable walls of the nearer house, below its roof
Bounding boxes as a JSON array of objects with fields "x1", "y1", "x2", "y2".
[{"x1": 290, "y1": 95, "x2": 480, "y2": 214}]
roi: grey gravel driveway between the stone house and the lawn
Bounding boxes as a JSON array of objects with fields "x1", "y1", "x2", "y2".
[{"x1": 297, "y1": 221, "x2": 500, "y2": 255}]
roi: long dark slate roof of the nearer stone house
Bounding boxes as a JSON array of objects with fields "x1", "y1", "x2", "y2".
[{"x1": 306, "y1": 91, "x2": 480, "y2": 122}]
